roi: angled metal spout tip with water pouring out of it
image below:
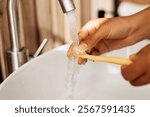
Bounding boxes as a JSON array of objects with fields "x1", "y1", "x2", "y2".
[{"x1": 59, "y1": 0, "x2": 76, "y2": 13}]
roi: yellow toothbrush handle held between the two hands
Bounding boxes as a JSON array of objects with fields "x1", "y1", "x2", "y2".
[{"x1": 80, "y1": 54, "x2": 132, "y2": 65}]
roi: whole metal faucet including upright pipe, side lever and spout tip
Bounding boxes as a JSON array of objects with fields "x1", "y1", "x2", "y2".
[{"x1": 7, "y1": 0, "x2": 75, "y2": 74}]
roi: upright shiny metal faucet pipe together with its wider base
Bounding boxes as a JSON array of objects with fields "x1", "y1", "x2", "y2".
[{"x1": 7, "y1": 0, "x2": 29, "y2": 74}]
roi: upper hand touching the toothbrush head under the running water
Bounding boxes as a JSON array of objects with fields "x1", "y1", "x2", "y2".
[{"x1": 67, "y1": 8, "x2": 150, "y2": 64}]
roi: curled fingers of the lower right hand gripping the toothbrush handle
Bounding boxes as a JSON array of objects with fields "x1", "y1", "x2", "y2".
[{"x1": 121, "y1": 54, "x2": 150, "y2": 86}]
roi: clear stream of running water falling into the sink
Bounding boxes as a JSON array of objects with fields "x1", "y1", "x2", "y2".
[{"x1": 66, "y1": 11, "x2": 80, "y2": 99}]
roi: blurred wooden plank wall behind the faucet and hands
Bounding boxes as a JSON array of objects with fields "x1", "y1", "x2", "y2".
[{"x1": 0, "y1": 0, "x2": 150, "y2": 82}]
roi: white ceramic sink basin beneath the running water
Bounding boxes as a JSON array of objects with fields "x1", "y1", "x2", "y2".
[{"x1": 0, "y1": 42, "x2": 150, "y2": 100}]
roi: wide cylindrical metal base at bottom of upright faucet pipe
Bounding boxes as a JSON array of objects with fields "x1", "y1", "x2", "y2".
[{"x1": 7, "y1": 48, "x2": 29, "y2": 74}]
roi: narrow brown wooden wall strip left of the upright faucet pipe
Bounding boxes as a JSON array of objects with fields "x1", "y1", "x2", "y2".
[{"x1": 0, "y1": 0, "x2": 10, "y2": 79}]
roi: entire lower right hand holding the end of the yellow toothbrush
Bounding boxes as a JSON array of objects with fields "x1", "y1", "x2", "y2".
[{"x1": 122, "y1": 44, "x2": 150, "y2": 86}]
